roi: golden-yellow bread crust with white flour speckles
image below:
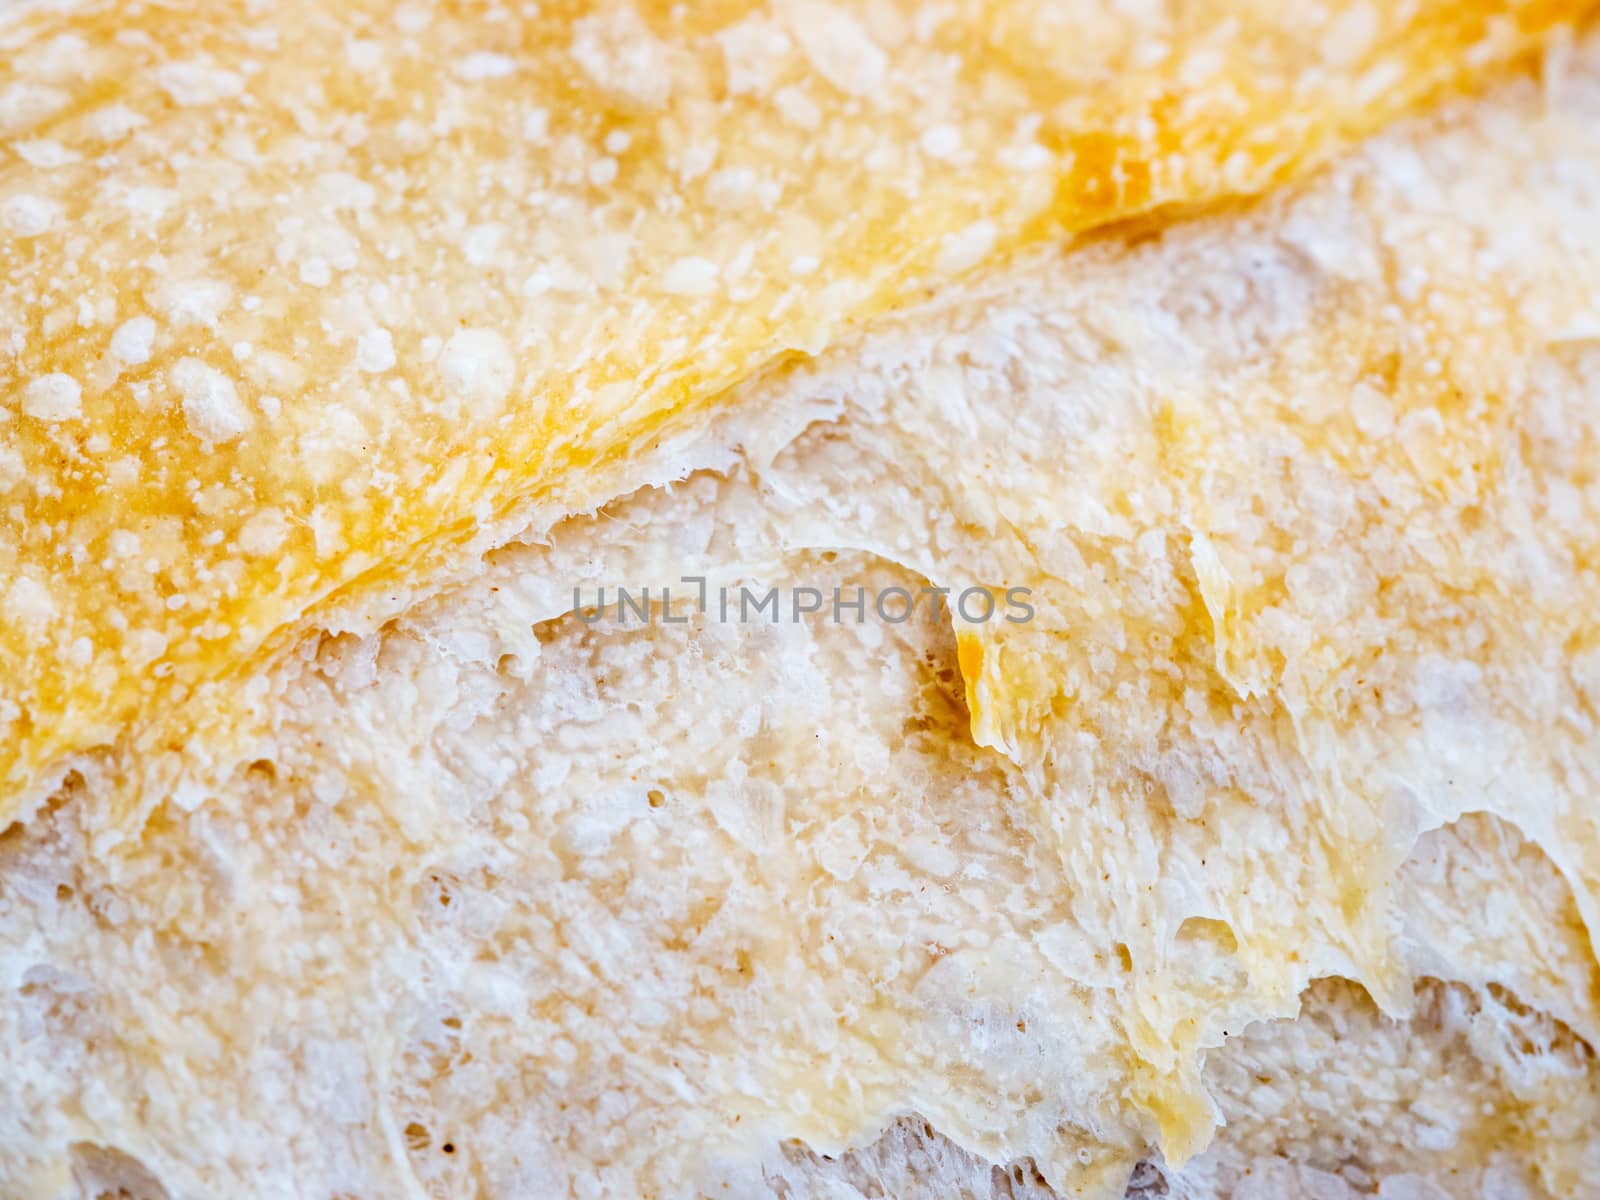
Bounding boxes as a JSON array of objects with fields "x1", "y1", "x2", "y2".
[{"x1": 0, "y1": 0, "x2": 1587, "y2": 822}]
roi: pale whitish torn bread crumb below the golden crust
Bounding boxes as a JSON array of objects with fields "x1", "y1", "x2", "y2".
[{"x1": 9, "y1": 21, "x2": 1600, "y2": 1200}]
